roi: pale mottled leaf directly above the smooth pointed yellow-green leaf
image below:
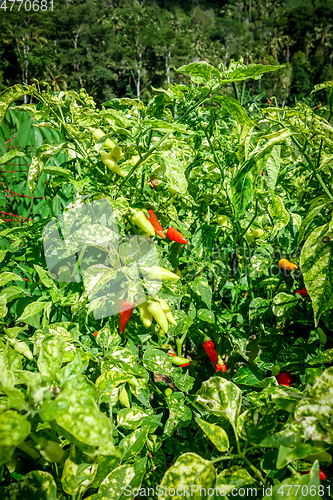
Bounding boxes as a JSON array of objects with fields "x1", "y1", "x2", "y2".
[{"x1": 195, "y1": 377, "x2": 242, "y2": 424}]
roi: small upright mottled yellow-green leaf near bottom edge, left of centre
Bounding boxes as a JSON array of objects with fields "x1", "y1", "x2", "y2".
[{"x1": 61, "y1": 445, "x2": 97, "y2": 496}]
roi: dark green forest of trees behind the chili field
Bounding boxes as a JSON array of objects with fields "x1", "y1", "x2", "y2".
[{"x1": 0, "y1": 0, "x2": 333, "y2": 105}]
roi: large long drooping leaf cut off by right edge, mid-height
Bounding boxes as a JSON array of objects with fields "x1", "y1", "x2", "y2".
[{"x1": 300, "y1": 224, "x2": 333, "y2": 327}]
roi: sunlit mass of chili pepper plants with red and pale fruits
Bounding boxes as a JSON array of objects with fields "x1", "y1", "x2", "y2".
[{"x1": 0, "y1": 61, "x2": 333, "y2": 500}]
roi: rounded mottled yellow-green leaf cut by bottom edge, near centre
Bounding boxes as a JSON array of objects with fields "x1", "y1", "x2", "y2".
[{"x1": 157, "y1": 453, "x2": 216, "y2": 500}]
